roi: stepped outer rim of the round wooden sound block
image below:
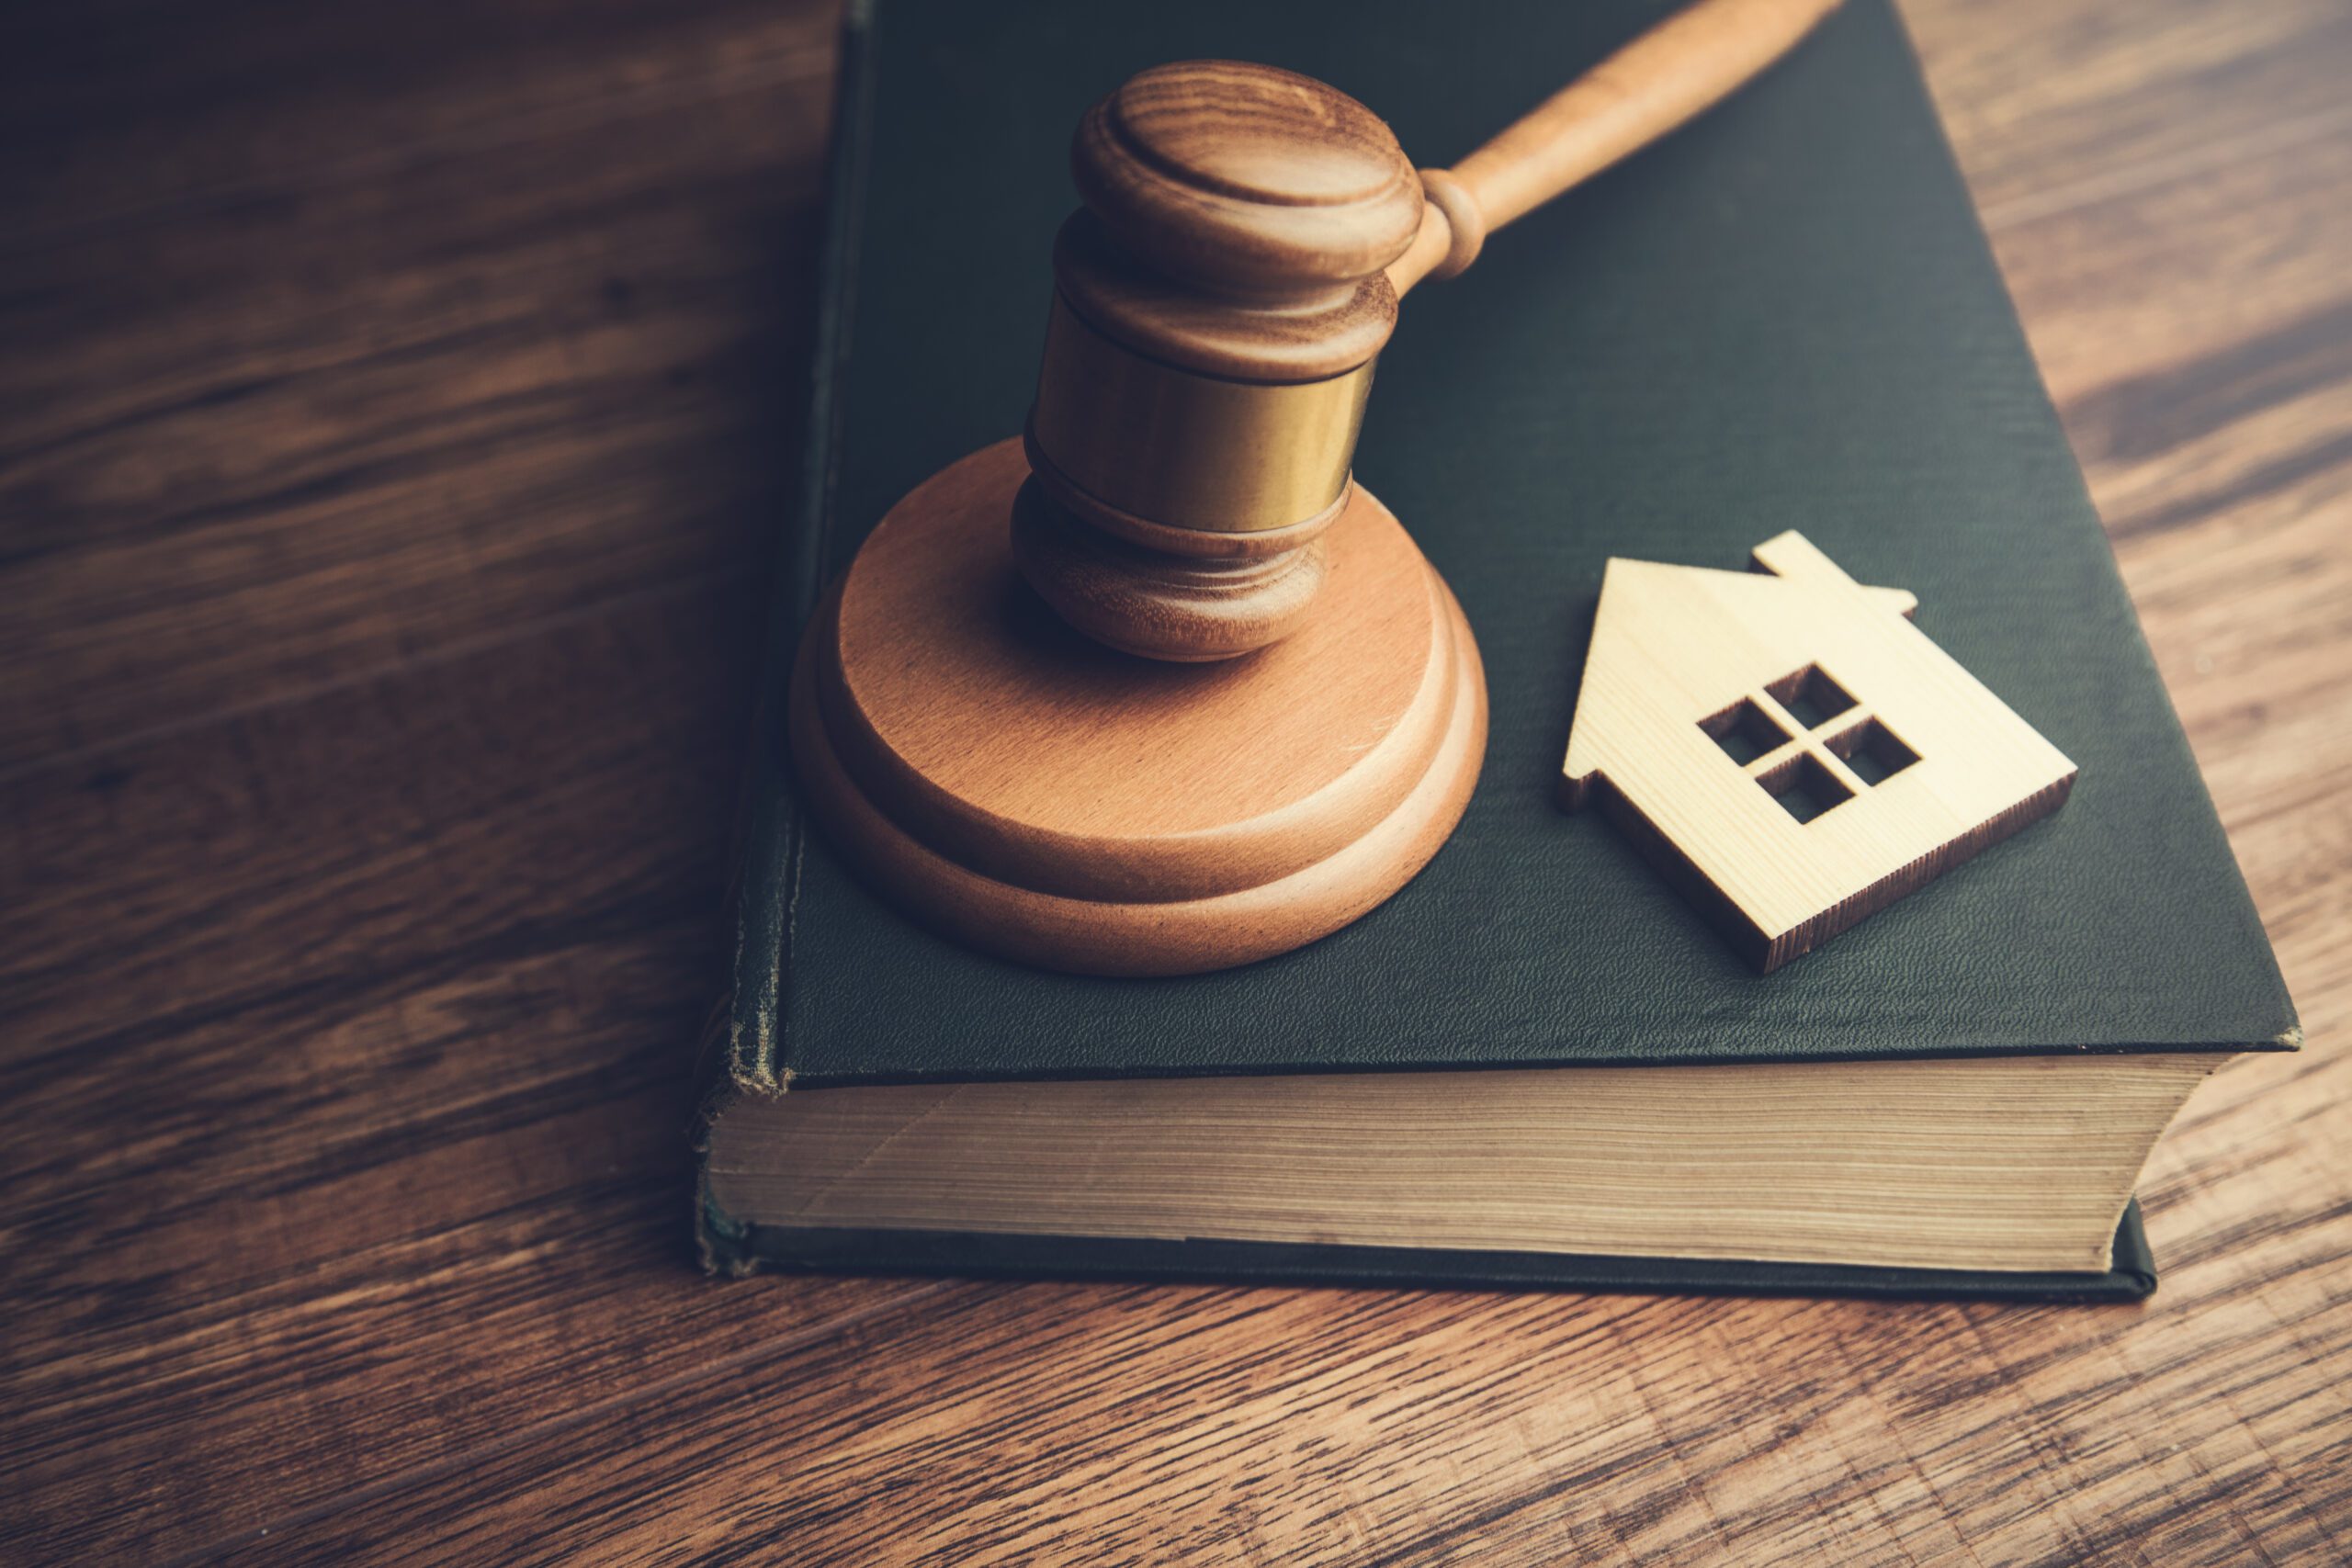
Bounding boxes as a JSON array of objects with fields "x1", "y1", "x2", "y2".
[{"x1": 788, "y1": 446, "x2": 1487, "y2": 976}]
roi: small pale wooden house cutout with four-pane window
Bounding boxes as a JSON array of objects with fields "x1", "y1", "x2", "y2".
[{"x1": 1562, "y1": 534, "x2": 2075, "y2": 971}]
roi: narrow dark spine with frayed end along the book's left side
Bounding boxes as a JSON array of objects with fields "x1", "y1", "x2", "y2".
[{"x1": 694, "y1": 0, "x2": 875, "y2": 1272}]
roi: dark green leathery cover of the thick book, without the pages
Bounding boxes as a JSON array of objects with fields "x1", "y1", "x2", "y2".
[{"x1": 698, "y1": 0, "x2": 2298, "y2": 1298}]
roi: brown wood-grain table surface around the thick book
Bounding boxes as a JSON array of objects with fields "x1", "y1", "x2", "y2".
[{"x1": 0, "y1": 0, "x2": 2352, "y2": 1563}]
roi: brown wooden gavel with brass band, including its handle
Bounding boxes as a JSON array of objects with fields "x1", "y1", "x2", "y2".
[{"x1": 1012, "y1": 0, "x2": 1837, "y2": 663}]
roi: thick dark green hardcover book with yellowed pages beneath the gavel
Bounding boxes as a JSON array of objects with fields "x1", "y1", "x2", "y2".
[{"x1": 696, "y1": 0, "x2": 2301, "y2": 1300}]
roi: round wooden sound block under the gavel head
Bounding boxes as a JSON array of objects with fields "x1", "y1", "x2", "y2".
[{"x1": 790, "y1": 440, "x2": 1487, "y2": 976}]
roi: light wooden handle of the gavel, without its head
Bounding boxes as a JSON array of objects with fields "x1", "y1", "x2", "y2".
[{"x1": 1387, "y1": 0, "x2": 1837, "y2": 294}]
